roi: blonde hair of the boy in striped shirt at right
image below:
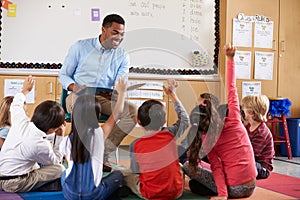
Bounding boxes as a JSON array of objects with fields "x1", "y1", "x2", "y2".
[{"x1": 242, "y1": 95, "x2": 270, "y2": 122}]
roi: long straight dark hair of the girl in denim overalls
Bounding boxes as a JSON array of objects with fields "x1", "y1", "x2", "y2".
[{"x1": 69, "y1": 95, "x2": 101, "y2": 163}]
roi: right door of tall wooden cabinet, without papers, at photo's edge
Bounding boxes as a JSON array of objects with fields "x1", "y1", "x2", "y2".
[{"x1": 278, "y1": 0, "x2": 300, "y2": 117}]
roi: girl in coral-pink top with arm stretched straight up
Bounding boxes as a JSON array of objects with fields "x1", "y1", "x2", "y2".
[{"x1": 185, "y1": 44, "x2": 257, "y2": 199}]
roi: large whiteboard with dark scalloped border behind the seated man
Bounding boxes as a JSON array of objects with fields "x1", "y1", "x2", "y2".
[{"x1": 0, "y1": 0, "x2": 219, "y2": 75}]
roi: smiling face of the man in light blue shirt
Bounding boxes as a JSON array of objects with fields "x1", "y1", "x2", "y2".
[{"x1": 101, "y1": 22, "x2": 125, "y2": 49}]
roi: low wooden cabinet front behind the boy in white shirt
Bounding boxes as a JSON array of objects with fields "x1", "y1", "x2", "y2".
[{"x1": 0, "y1": 76, "x2": 56, "y2": 117}]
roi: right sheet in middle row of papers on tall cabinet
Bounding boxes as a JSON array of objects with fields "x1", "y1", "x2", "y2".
[{"x1": 254, "y1": 51, "x2": 274, "y2": 80}]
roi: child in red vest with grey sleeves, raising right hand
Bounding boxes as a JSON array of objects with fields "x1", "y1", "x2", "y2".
[{"x1": 118, "y1": 80, "x2": 188, "y2": 199}]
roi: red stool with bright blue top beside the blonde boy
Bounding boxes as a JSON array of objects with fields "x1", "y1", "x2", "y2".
[{"x1": 267, "y1": 98, "x2": 292, "y2": 159}]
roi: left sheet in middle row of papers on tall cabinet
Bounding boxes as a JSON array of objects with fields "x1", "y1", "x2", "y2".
[{"x1": 234, "y1": 51, "x2": 251, "y2": 79}]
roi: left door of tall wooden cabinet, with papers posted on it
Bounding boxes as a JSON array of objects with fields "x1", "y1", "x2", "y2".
[{"x1": 219, "y1": 0, "x2": 280, "y2": 98}]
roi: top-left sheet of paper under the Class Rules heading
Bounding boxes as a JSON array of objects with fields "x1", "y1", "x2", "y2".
[{"x1": 232, "y1": 19, "x2": 252, "y2": 47}]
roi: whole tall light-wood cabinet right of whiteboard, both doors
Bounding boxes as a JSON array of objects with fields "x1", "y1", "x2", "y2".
[{"x1": 219, "y1": 0, "x2": 300, "y2": 117}]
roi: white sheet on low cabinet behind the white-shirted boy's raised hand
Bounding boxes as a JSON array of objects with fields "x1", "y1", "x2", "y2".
[{"x1": 4, "y1": 79, "x2": 35, "y2": 104}]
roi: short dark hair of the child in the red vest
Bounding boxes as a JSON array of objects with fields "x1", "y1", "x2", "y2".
[{"x1": 137, "y1": 99, "x2": 166, "y2": 130}]
